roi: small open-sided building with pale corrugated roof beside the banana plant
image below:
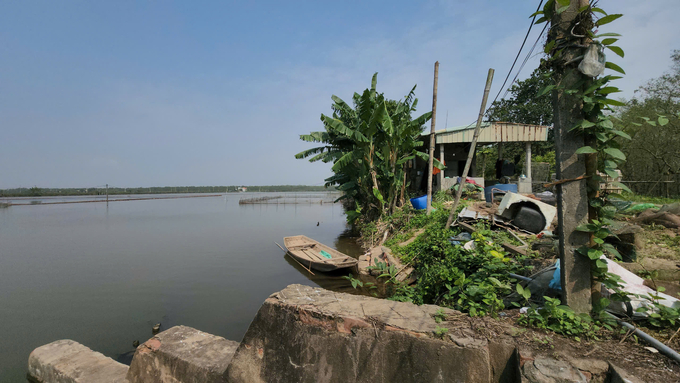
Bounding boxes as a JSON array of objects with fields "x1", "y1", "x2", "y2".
[{"x1": 411, "y1": 122, "x2": 551, "y2": 193}]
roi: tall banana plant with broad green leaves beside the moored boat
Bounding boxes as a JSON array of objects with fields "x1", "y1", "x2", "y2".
[{"x1": 295, "y1": 73, "x2": 443, "y2": 221}]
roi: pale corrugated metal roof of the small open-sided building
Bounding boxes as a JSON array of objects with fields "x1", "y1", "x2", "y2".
[{"x1": 423, "y1": 122, "x2": 550, "y2": 144}]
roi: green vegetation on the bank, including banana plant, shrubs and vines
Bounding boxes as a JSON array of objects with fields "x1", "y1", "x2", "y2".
[{"x1": 296, "y1": 1, "x2": 680, "y2": 354}]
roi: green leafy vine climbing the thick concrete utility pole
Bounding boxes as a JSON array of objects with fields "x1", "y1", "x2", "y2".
[{"x1": 532, "y1": 0, "x2": 630, "y2": 314}]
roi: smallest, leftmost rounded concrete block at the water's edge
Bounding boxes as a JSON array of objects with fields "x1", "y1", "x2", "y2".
[{"x1": 28, "y1": 339, "x2": 128, "y2": 383}]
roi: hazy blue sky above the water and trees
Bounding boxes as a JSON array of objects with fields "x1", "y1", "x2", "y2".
[{"x1": 0, "y1": 0, "x2": 680, "y2": 189}]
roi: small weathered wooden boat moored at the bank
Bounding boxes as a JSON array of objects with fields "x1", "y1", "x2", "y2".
[{"x1": 283, "y1": 235, "x2": 357, "y2": 272}]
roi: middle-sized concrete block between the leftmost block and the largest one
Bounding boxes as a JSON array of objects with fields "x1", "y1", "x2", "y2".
[{"x1": 127, "y1": 326, "x2": 238, "y2": 383}]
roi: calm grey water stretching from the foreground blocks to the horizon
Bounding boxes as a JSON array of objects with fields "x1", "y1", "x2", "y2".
[{"x1": 0, "y1": 193, "x2": 360, "y2": 382}]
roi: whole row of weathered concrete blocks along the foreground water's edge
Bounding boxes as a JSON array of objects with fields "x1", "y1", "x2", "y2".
[{"x1": 28, "y1": 285, "x2": 652, "y2": 383}]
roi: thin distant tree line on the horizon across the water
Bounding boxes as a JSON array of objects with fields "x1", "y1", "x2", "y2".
[{"x1": 0, "y1": 185, "x2": 335, "y2": 197}]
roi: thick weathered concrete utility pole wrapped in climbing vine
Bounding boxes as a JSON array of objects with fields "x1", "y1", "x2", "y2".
[{"x1": 548, "y1": 0, "x2": 592, "y2": 313}]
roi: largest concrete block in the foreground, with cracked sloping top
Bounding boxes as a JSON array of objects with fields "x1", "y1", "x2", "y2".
[{"x1": 225, "y1": 285, "x2": 496, "y2": 383}]
